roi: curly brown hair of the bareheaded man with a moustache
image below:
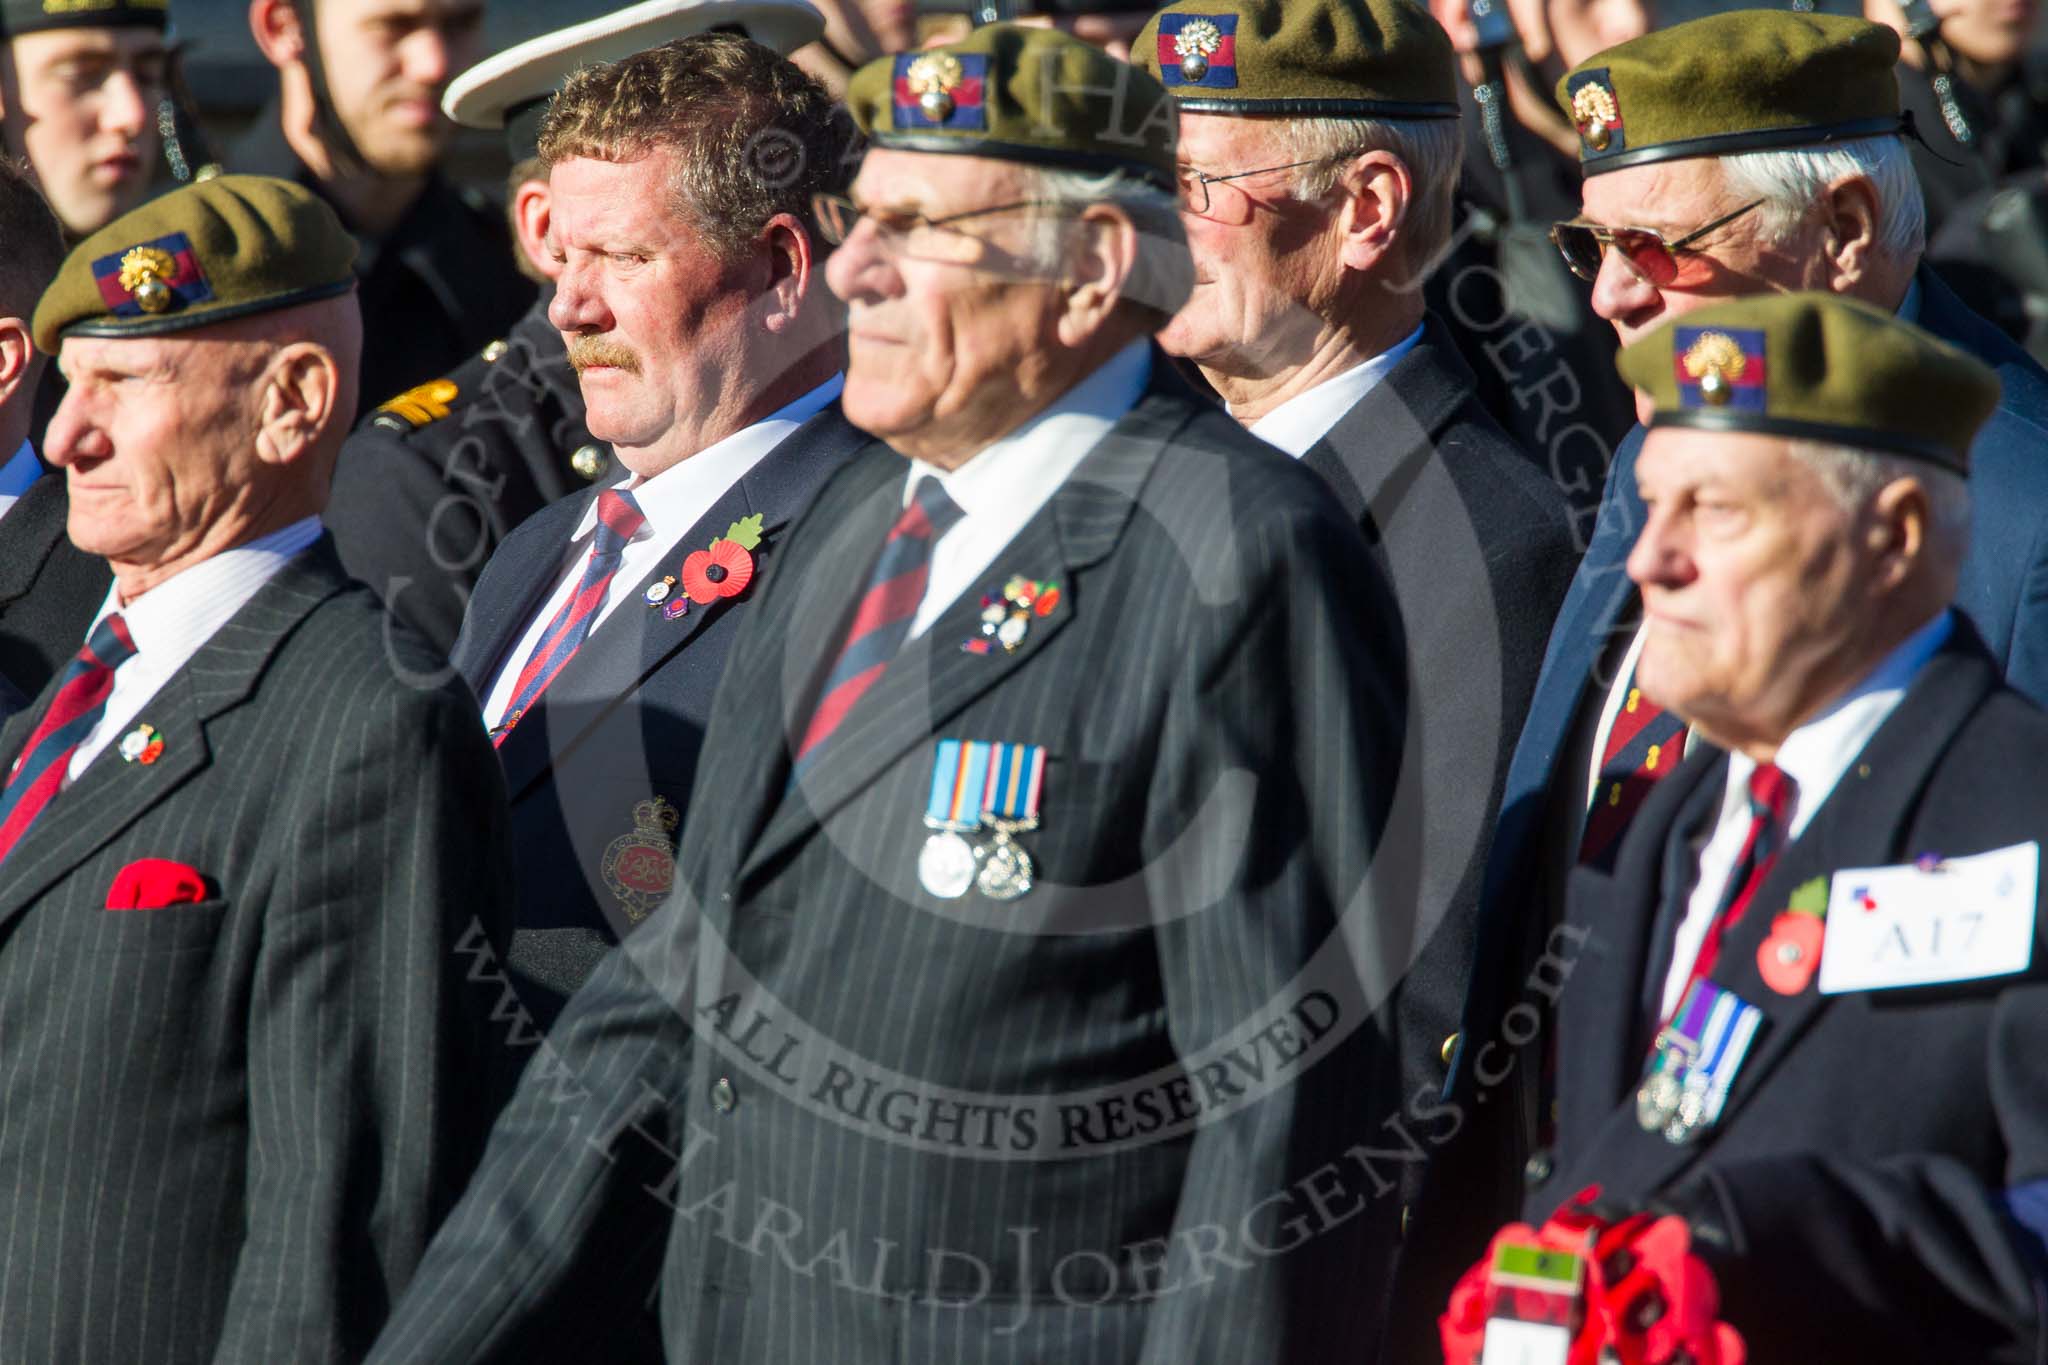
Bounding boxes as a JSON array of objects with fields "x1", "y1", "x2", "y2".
[{"x1": 541, "y1": 33, "x2": 858, "y2": 262}]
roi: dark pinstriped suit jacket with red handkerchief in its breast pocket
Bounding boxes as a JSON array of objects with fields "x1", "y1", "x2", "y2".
[{"x1": 0, "y1": 538, "x2": 508, "y2": 1365}]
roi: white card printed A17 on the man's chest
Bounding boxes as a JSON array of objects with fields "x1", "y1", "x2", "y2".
[{"x1": 1821, "y1": 843, "x2": 2042, "y2": 995}]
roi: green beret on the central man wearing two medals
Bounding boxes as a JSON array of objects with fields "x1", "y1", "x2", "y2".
[{"x1": 846, "y1": 25, "x2": 1176, "y2": 190}]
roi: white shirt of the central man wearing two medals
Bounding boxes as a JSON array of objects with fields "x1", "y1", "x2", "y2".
[{"x1": 903, "y1": 342, "x2": 1151, "y2": 639}]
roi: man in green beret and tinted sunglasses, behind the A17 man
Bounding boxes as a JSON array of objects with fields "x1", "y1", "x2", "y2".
[{"x1": 1430, "y1": 10, "x2": 2048, "y2": 1350}]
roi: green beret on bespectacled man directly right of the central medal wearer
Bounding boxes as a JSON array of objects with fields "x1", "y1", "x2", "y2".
[{"x1": 1130, "y1": 0, "x2": 1458, "y2": 119}]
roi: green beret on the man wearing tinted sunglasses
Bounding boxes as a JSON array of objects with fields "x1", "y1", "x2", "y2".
[{"x1": 1556, "y1": 10, "x2": 1903, "y2": 176}]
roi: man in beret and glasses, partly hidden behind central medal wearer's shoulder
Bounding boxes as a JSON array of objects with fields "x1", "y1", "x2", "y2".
[{"x1": 1139, "y1": 0, "x2": 1577, "y2": 1277}]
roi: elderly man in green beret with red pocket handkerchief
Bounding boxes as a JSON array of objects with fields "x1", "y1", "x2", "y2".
[{"x1": 0, "y1": 176, "x2": 510, "y2": 1365}]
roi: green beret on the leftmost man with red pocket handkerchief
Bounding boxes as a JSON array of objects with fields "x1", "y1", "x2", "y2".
[{"x1": 35, "y1": 176, "x2": 356, "y2": 354}]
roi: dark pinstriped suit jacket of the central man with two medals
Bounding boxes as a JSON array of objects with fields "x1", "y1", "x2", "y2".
[{"x1": 373, "y1": 364, "x2": 1403, "y2": 1365}]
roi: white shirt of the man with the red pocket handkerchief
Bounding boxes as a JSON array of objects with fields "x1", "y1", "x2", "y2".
[{"x1": 63, "y1": 516, "x2": 319, "y2": 786}]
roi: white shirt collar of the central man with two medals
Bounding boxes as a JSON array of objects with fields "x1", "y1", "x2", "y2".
[{"x1": 903, "y1": 340, "x2": 1151, "y2": 516}]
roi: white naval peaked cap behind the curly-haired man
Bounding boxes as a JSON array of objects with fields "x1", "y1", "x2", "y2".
[{"x1": 440, "y1": 0, "x2": 825, "y2": 129}]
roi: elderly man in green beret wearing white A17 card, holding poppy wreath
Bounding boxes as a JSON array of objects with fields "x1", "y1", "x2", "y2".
[{"x1": 1444, "y1": 293, "x2": 2048, "y2": 1365}]
